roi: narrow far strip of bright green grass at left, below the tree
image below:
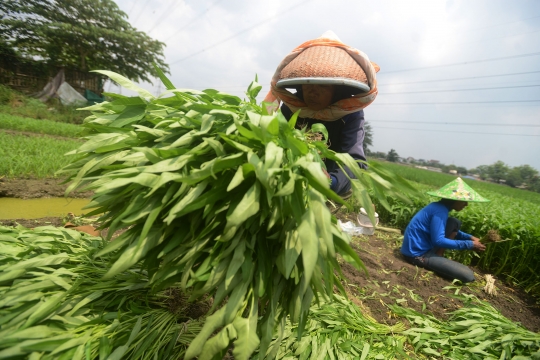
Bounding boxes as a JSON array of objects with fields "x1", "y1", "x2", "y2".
[{"x1": 0, "y1": 113, "x2": 81, "y2": 138}]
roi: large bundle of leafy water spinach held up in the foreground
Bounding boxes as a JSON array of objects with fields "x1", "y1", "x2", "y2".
[{"x1": 64, "y1": 71, "x2": 413, "y2": 359}]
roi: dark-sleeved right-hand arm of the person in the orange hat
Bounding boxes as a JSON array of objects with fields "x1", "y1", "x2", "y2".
[{"x1": 328, "y1": 110, "x2": 366, "y2": 194}]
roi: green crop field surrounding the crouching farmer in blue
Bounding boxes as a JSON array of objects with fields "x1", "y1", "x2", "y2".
[{"x1": 372, "y1": 163, "x2": 540, "y2": 297}]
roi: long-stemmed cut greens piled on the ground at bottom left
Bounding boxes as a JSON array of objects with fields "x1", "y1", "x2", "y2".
[{"x1": 0, "y1": 226, "x2": 201, "y2": 360}]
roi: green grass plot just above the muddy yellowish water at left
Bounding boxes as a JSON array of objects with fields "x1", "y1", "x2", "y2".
[{"x1": 0, "y1": 132, "x2": 81, "y2": 179}]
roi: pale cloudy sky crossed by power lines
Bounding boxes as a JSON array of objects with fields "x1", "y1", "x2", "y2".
[{"x1": 109, "y1": 0, "x2": 540, "y2": 170}]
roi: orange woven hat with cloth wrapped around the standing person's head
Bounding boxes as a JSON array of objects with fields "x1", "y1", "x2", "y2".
[{"x1": 264, "y1": 31, "x2": 379, "y2": 121}]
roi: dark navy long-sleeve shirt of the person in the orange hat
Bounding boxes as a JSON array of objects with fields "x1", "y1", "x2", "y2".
[{"x1": 281, "y1": 104, "x2": 366, "y2": 195}]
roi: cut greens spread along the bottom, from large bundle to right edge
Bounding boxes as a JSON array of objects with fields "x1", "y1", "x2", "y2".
[{"x1": 254, "y1": 295, "x2": 540, "y2": 360}]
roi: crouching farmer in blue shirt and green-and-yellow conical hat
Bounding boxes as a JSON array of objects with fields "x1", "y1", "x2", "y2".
[{"x1": 401, "y1": 177, "x2": 489, "y2": 282}]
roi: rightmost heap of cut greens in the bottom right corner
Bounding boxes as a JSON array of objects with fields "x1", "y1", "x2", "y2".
[{"x1": 390, "y1": 295, "x2": 540, "y2": 359}]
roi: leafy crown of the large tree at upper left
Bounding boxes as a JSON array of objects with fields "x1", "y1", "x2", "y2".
[{"x1": 0, "y1": 0, "x2": 168, "y2": 81}]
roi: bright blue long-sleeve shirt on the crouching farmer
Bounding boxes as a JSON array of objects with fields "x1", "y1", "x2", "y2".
[{"x1": 401, "y1": 202, "x2": 473, "y2": 257}]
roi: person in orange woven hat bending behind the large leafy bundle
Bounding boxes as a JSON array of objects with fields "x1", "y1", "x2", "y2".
[{"x1": 265, "y1": 31, "x2": 379, "y2": 197}]
